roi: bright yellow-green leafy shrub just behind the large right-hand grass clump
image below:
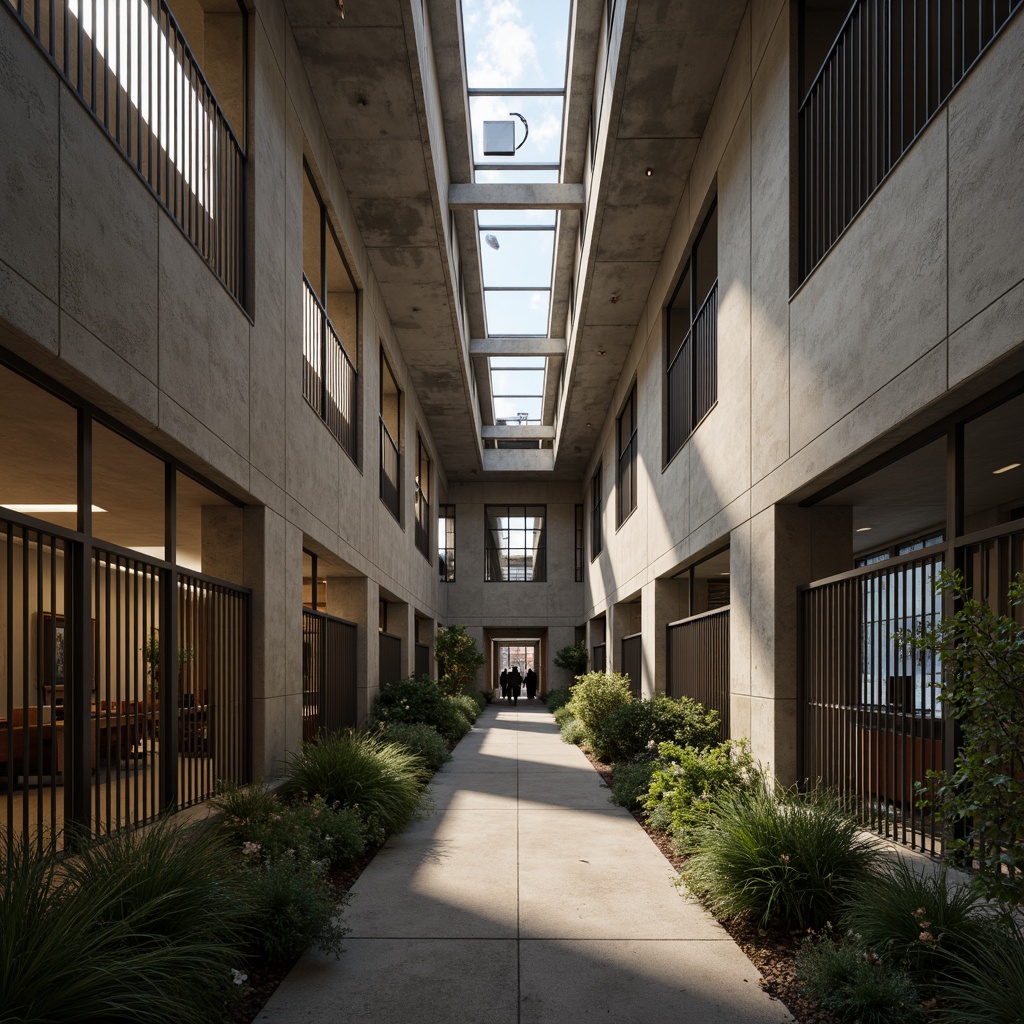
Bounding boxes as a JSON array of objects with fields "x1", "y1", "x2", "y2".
[{"x1": 642, "y1": 739, "x2": 758, "y2": 846}]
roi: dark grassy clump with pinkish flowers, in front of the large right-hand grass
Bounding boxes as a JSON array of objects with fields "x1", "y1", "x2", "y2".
[{"x1": 841, "y1": 857, "x2": 991, "y2": 984}]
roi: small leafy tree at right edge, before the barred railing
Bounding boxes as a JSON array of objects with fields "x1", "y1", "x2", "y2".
[{"x1": 898, "y1": 570, "x2": 1024, "y2": 907}]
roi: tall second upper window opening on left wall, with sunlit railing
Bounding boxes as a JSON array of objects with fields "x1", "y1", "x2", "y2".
[{"x1": 302, "y1": 163, "x2": 359, "y2": 461}]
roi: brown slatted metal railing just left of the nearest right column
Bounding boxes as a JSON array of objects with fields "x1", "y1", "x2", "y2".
[{"x1": 665, "y1": 608, "x2": 730, "y2": 739}]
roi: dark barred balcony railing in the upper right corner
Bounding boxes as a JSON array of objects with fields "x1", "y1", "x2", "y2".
[{"x1": 799, "y1": 0, "x2": 1024, "y2": 280}]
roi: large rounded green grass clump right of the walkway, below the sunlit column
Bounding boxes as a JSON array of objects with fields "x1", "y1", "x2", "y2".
[{"x1": 684, "y1": 779, "x2": 879, "y2": 928}]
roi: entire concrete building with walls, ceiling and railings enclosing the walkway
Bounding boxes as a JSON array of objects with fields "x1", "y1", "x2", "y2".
[{"x1": 0, "y1": 0, "x2": 1024, "y2": 851}]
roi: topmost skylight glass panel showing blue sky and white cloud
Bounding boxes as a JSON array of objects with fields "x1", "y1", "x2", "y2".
[{"x1": 462, "y1": 0, "x2": 569, "y2": 89}]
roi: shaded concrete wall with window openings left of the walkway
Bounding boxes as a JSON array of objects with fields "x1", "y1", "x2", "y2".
[{"x1": 0, "y1": 0, "x2": 444, "y2": 775}]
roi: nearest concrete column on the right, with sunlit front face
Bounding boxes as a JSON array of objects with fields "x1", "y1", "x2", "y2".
[{"x1": 730, "y1": 505, "x2": 853, "y2": 783}]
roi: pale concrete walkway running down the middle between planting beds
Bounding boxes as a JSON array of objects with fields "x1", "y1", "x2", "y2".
[{"x1": 257, "y1": 700, "x2": 792, "y2": 1024}]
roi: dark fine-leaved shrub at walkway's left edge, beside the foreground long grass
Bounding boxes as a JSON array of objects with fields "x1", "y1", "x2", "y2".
[{"x1": 245, "y1": 852, "x2": 348, "y2": 961}]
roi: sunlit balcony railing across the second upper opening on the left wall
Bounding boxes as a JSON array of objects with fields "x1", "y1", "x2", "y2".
[{"x1": 302, "y1": 274, "x2": 359, "y2": 462}]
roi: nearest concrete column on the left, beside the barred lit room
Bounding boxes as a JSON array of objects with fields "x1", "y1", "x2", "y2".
[{"x1": 243, "y1": 506, "x2": 302, "y2": 778}]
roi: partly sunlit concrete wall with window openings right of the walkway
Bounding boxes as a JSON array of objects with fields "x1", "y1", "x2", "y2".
[{"x1": 580, "y1": 0, "x2": 1024, "y2": 778}]
